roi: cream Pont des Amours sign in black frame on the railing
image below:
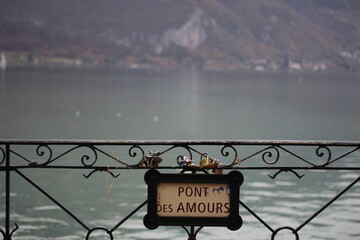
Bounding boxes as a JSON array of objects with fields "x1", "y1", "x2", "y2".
[{"x1": 144, "y1": 170, "x2": 244, "y2": 230}]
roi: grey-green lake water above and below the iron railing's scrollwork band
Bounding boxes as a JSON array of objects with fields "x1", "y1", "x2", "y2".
[{"x1": 0, "y1": 69, "x2": 360, "y2": 240}]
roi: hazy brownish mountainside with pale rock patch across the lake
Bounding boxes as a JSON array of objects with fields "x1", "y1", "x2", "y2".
[{"x1": 0, "y1": 0, "x2": 360, "y2": 70}]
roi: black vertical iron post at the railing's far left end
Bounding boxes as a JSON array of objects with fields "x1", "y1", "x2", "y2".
[{"x1": 5, "y1": 144, "x2": 10, "y2": 240}]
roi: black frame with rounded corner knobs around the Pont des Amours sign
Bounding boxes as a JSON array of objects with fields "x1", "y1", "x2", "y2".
[{"x1": 143, "y1": 169, "x2": 244, "y2": 231}]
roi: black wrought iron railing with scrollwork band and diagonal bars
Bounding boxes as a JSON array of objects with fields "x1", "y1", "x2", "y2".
[{"x1": 0, "y1": 140, "x2": 360, "y2": 240}]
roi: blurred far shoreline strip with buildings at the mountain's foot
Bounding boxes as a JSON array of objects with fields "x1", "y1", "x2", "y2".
[{"x1": 0, "y1": 51, "x2": 360, "y2": 73}]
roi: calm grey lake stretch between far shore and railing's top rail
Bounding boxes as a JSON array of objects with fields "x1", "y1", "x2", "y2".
[{"x1": 0, "y1": 70, "x2": 360, "y2": 140}]
